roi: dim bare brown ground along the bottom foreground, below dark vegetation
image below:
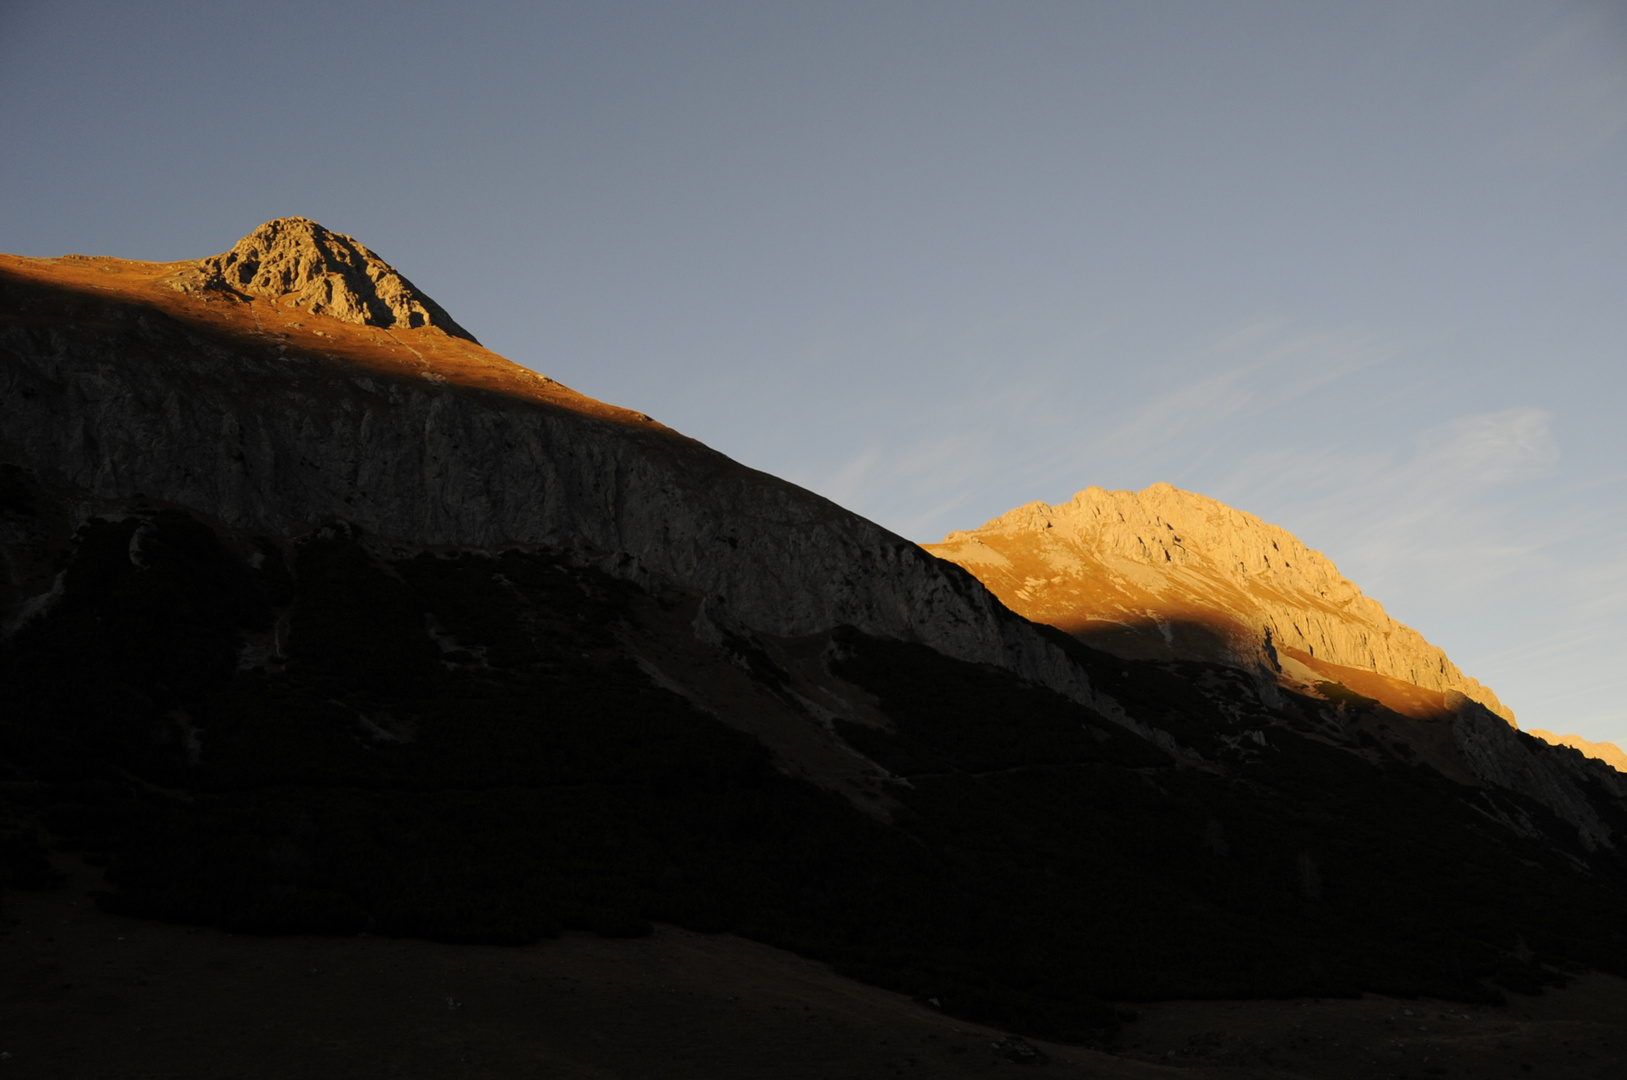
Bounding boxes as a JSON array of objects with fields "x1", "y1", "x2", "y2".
[{"x1": 0, "y1": 867, "x2": 1627, "y2": 1080}]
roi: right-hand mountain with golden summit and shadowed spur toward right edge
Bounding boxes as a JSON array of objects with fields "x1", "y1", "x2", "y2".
[{"x1": 924, "y1": 483, "x2": 1620, "y2": 826}]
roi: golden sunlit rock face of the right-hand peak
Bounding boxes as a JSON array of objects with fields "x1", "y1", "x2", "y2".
[{"x1": 927, "y1": 483, "x2": 1513, "y2": 722}]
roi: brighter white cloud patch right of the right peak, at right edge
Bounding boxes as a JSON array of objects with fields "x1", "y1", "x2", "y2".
[{"x1": 1214, "y1": 407, "x2": 1627, "y2": 745}]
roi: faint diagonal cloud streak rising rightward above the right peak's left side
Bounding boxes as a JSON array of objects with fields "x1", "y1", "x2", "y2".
[{"x1": 796, "y1": 320, "x2": 1388, "y2": 540}]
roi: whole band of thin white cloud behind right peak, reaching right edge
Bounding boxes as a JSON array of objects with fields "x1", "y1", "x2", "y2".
[{"x1": 809, "y1": 313, "x2": 1627, "y2": 740}]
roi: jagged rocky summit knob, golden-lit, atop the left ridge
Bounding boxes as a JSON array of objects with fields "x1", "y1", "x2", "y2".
[{"x1": 168, "y1": 218, "x2": 475, "y2": 342}]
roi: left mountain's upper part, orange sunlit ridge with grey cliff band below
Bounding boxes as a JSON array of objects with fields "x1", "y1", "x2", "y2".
[{"x1": 0, "y1": 220, "x2": 1111, "y2": 708}]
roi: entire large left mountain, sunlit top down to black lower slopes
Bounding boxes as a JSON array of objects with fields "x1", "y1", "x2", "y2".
[{"x1": 0, "y1": 220, "x2": 1627, "y2": 1043}]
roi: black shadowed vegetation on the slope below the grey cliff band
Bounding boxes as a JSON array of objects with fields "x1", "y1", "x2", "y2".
[{"x1": 0, "y1": 485, "x2": 1627, "y2": 1039}]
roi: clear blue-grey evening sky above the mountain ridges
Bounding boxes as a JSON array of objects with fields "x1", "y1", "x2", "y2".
[{"x1": 0, "y1": 0, "x2": 1627, "y2": 745}]
